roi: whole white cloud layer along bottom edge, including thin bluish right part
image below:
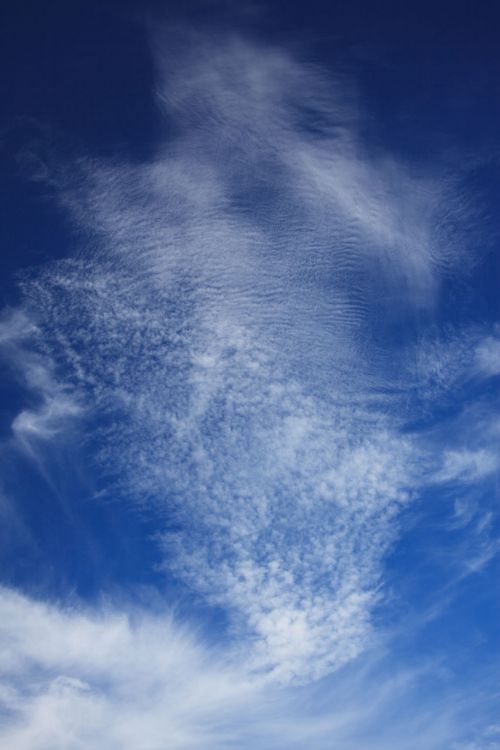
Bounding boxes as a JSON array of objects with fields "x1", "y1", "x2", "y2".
[{"x1": 0, "y1": 588, "x2": 496, "y2": 750}]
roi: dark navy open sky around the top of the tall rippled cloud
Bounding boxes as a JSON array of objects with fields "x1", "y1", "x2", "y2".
[{"x1": 0, "y1": 2, "x2": 500, "y2": 314}]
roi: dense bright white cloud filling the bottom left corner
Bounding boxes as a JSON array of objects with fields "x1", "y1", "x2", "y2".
[{"x1": 0, "y1": 589, "x2": 256, "y2": 750}]
